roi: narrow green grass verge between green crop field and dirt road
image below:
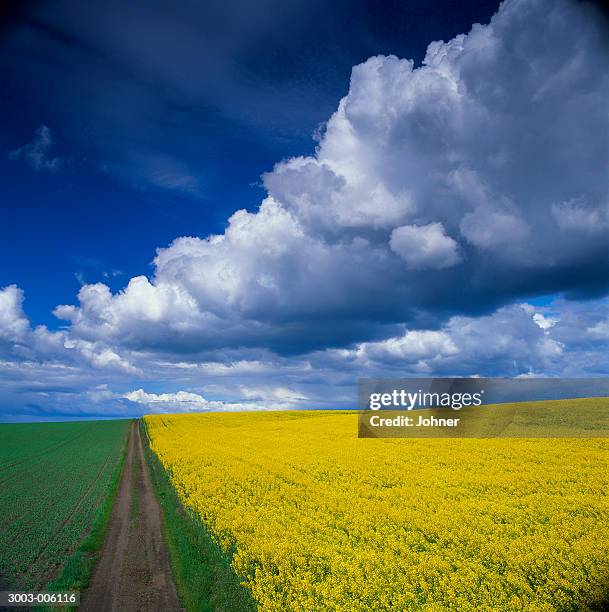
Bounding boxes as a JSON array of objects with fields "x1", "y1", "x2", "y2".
[{"x1": 34, "y1": 418, "x2": 131, "y2": 612}]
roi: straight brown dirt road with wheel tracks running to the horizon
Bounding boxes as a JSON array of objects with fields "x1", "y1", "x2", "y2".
[{"x1": 79, "y1": 422, "x2": 181, "y2": 612}]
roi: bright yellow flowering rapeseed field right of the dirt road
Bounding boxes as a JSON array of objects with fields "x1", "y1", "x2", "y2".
[{"x1": 145, "y1": 411, "x2": 609, "y2": 612}]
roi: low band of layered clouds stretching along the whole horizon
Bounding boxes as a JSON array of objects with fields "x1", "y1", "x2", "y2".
[{"x1": 0, "y1": 286, "x2": 609, "y2": 418}]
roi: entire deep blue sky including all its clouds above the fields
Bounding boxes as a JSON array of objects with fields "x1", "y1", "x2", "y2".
[{"x1": 0, "y1": 0, "x2": 609, "y2": 419}]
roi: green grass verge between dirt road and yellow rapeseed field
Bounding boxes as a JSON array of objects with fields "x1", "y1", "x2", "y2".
[{"x1": 140, "y1": 421, "x2": 256, "y2": 612}]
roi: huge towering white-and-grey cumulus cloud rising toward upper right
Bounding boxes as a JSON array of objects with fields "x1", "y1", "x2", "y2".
[{"x1": 56, "y1": 0, "x2": 609, "y2": 353}]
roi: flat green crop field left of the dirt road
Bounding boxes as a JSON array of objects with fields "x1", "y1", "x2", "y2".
[{"x1": 0, "y1": 420, "x2": 131, "y2": 589}]
